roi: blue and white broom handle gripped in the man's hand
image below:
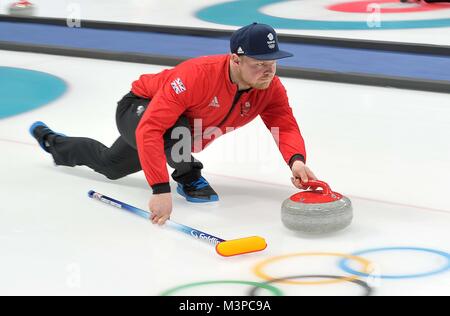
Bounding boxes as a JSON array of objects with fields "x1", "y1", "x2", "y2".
[{"x1": 88, "y1": 191, "x2": 225, "y2": 246}]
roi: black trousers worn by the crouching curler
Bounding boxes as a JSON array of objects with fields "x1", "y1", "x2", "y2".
[{"x1": 49, "y1": 93, "x2": 203, "y2": 184}]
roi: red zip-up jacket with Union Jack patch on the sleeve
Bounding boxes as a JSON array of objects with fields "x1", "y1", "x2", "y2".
[{"x1": 132, "y1": 55, "x2": 306, "y2": 191}]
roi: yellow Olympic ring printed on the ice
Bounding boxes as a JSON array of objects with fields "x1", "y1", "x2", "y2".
[{"x1": 253, "y1": 252, "x2": 372, "y2": 285}]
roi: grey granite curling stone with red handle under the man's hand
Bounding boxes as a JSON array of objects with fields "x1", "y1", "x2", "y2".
[{"x1": 281, "y1": 181, "x2": 353, "y2": 234}]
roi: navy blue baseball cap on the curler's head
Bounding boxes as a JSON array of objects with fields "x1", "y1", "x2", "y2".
[{"x1": 230, "y1": 22, "x2": 294, "y2": 60}]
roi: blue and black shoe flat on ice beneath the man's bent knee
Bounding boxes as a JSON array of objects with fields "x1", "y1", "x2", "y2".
[{"x1": 177, "y1": 177, "x2": 219, "y2": 203}]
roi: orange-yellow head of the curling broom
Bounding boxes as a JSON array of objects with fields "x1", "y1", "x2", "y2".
[{"x1": 216, "y1": 236, "x2": 267, "y2": 257}]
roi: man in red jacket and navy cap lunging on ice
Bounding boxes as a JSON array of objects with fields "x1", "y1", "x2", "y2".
[{"x1": 30, "y1": 23, "x2": 316, "y2": 225}]
